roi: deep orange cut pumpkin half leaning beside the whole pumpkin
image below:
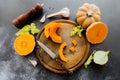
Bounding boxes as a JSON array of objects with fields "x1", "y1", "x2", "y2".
[{"x1": 86, "y1": 22, "x2": 108, "y2": 44}]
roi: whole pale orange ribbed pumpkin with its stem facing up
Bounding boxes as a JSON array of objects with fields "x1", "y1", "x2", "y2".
[{"x1": 76, "y1": 3, "x2": 101, "y2": 28}]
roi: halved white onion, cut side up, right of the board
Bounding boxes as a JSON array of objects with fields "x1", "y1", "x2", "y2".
[{"x1": 93, "y1": 50, "x2": 110, "y2": 65}]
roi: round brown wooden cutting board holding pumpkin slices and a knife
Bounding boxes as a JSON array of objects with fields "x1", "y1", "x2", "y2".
[{"x1": 36, "y1": 20, "x2": 90, "y2": 73}]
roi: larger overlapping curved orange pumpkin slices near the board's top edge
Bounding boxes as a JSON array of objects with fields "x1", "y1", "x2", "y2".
[{"x1": 44, "y1": 22, "x2": 62, "y2": 43}]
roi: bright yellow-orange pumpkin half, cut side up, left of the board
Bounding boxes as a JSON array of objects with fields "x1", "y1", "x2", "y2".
[{"x1": 14, "y1": 33, "x2": 35, "y2": 56}]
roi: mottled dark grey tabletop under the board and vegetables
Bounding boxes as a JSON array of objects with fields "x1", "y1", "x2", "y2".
[{"x1": 0, "y1": 0, "x2": 120, "y2": 80}]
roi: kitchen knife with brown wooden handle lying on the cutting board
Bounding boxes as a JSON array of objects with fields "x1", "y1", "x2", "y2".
[{"x1": 37, "y1": 40, "x2": 73, "y2": 73}]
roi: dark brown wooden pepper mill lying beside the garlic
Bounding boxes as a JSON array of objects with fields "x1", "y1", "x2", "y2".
[{"x1": 12, "y1": 3, "x2": 43, "y2": 28}]
